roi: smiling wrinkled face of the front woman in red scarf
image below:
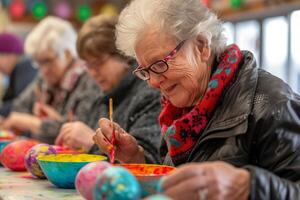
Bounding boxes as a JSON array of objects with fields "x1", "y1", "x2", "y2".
[{"x1": 135, "y1": 30, "x2": 210, "y2": 107}]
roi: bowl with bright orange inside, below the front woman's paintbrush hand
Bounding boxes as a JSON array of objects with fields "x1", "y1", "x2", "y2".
[{"x1": 117, "y1": 164, "x2": 175, "y2": 197}]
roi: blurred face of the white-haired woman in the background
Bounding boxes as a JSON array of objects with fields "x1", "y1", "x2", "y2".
[{"x1": 34, "y1": 51, "x2": 71, "y2": 86}]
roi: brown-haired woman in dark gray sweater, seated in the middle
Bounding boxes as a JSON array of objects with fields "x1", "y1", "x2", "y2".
[{"x1": 56, "y1": 15, "x2": 161, "y2": 162}]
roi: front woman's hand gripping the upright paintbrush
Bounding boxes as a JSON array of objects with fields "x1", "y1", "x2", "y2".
[{"x1": 94, "y1": 118, "x2": 145, "y2": 163}]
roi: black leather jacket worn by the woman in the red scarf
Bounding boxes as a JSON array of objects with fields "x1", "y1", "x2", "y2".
[{"x1": 161, "y1": 52, "x2": 300, "y2": 200}]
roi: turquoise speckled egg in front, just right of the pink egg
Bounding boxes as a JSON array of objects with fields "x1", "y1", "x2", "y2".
[{"x1": 93, "y1": 167, "x2": 141, "y2": 200}]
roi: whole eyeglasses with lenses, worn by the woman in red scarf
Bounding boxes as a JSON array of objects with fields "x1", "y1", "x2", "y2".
[{"x1": 132, "y1": 40, "x2": 186, "y2": 81}]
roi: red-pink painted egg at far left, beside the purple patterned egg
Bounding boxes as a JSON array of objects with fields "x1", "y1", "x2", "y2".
[{"x1": 1, "y1": 140, "x2": 38, "y2": 171}]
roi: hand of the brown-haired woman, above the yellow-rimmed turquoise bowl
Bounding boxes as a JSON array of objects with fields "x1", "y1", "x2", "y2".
[{"x1": 55, "y1": 122, "x2": 95, "y2": 152}]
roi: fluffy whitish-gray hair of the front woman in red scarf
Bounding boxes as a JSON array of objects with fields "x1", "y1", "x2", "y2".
[{"x1": 116, "y1": 0, "x2": 226, "y2": 61}]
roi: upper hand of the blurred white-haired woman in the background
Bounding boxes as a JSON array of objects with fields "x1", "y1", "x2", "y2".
[{"x1": 33, "y1": 102, "x2": 62, "y2": 120}]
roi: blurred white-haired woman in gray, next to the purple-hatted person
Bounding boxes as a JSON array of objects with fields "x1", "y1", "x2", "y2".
[{"x1": 3, "y1": 17, "x2": 101, "y2": 143}]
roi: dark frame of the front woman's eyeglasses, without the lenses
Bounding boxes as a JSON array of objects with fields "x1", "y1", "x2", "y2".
[{"x1": 132, "y1": 40, "x2": 186, "y2": 81}]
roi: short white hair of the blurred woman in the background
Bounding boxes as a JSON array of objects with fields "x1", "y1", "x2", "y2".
[{"x1": 25, "y1": 16, "x2": 77, "y2": 57}]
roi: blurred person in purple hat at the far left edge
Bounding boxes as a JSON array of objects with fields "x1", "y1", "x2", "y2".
[{"x1": 0, "y1": 32, "x2": 37, "y2": 117}]
